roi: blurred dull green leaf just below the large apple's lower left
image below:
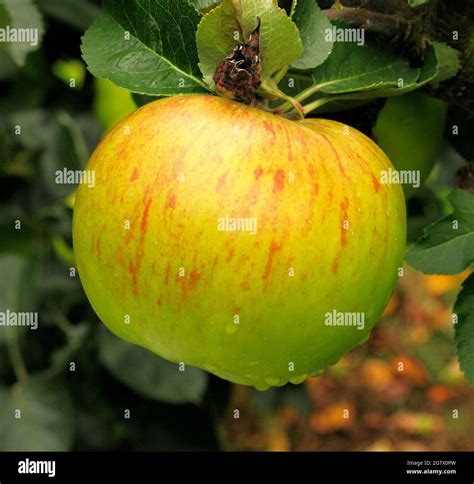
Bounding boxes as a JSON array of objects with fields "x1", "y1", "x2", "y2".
[{"x1": 99, "y1": 333, "x2": 207, "y2": 403}]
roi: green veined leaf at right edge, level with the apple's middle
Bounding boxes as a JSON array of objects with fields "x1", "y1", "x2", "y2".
[{"x1": 406, "y1": 189, "x2": 474, "y2": 274}]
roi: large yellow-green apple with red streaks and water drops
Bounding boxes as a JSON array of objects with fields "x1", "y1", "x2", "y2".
[{"x1": 73, "y1": 95, "x2": 406, "y2": 390}]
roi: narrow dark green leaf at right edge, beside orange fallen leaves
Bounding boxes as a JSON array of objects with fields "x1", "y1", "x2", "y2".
[{"x1": 454, "y1": 274, "x2": 474, "y2": 386}]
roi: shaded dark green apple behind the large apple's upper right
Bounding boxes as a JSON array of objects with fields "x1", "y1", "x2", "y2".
[{"x1": 373, "y1": 92, "x2": 447, "y2": 198}]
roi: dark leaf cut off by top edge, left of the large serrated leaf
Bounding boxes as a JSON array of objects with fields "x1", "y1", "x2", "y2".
[{"x1": 35, "y1": 0, "x2": 100, "y2": 32}]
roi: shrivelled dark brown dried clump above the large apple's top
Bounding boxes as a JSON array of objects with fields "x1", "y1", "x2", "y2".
[{"x1": 214, "y1": 18, "x2": 262, "y2": 104}]
